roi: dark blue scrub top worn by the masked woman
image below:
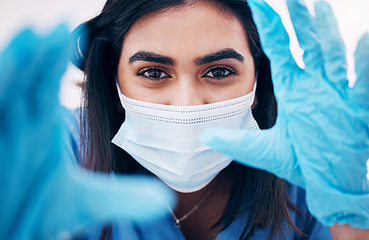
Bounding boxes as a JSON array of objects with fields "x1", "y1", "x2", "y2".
[{"x1": 65, "y1": 110, "x2": 332, "y2": 240}]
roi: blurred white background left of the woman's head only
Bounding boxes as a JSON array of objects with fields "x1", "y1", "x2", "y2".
[{"x1": 0, "y1": 0, "x2": 105, "y2": 108}]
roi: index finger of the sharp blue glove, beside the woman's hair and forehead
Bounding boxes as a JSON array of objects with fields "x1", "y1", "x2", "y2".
[{"x1": 247, "y1": 0, "x2": 297, "y2": 76}]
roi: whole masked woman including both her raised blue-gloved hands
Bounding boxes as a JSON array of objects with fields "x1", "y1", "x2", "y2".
[{"x1": 0, "y1": 0, "x2": 369, "y2": 239}]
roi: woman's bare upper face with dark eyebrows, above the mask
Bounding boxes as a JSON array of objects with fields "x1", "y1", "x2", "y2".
[{"x1": 118, "y1": 2, "x2": 255, "y2": 106}]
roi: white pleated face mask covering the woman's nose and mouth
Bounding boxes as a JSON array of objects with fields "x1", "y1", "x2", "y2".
[{"x1": 112, "y1": 85, "x2": 259, "y2": 192}]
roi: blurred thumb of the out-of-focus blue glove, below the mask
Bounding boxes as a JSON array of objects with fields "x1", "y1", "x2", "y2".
[{"x1": 74, "y1": 173, "x2": 176, "y2": 222}]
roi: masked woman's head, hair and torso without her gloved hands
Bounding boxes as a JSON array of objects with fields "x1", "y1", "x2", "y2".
[{"x1": 67, "y1": 0, "x2": 340, "y2": 239}]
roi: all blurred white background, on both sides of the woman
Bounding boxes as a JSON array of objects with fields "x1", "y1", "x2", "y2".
[{"x1": 0, "y1": 0, "x2": 369, "y2": 108}]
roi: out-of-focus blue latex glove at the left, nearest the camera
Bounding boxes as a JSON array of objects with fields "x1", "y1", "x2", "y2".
[{"x1": 0, "y1": 26, "x2": 174, "y2": 240}]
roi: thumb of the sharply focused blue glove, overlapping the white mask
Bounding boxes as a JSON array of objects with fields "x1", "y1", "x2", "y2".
[{"x1": 200, "y1": 128, "x2": 304, "y2": 187}]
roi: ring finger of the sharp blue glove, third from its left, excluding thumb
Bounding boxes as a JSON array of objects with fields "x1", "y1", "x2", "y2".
[{"x1": 313, "y1": 1, "x2": 348, "y2": 91}]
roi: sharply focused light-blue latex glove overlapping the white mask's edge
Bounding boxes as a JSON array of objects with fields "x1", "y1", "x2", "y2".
[{"x1": 201, "y1": 0, "x2": 369, "y2": 228}]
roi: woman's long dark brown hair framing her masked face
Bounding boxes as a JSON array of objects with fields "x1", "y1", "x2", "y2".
[{"x1": 77, "y1": 0, "x2": 301, "y2": 239}]
